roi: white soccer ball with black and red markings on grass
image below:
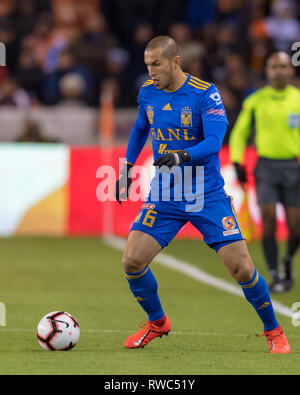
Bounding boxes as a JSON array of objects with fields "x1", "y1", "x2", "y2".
[{"x1": 37, "y1": 311, "x2": 80, "y2": 351}]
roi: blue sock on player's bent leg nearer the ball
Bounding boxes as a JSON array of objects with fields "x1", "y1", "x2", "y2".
[{"x1": 126, "y1": 266, "x2": 165, "y2": 321}]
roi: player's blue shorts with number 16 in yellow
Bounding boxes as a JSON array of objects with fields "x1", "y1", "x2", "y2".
[{"x1": 131, "y1": 191, "x2": 245, "y2": 252}]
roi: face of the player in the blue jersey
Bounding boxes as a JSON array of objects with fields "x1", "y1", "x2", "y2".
[{"x1": 145, "y1": 48, "x2": 176, "y2": 90}]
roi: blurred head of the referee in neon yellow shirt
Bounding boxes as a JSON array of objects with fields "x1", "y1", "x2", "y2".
[{"x1": 266, "y1": 53, "x2": 294, "y2": 89}]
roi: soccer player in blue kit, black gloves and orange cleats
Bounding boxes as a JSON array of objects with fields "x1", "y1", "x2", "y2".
[{"x1": 116, "y1": 36, "x2": 290, "y2": 353}]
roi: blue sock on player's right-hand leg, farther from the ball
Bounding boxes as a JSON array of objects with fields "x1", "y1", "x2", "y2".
[{"x1": 239, "y1": 269, "x2": 279, "y2": 331}]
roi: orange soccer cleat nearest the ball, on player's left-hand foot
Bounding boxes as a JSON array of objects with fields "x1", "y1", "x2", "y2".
[{"x1": 124, "y1": 316, "x2": 171, "y2": 348}]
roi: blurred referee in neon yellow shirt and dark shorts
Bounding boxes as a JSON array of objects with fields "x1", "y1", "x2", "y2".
[{"x1": 230, "y1": 52, "x2": 300, "y2": 293}]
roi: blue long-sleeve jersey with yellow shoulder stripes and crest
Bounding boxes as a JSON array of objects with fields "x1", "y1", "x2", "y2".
[{"x1": 126, "y1": 75, "x2": 228, "y2": 200}]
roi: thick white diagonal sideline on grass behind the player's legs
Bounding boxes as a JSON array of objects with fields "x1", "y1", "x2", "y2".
[{"x1": 103, "y1": 237, "x2": 294, "y2": 318}]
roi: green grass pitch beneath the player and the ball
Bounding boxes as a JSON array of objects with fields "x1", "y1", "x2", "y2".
[{"x1": 0, "y1": 238, "x2": 300, "y2": 375}]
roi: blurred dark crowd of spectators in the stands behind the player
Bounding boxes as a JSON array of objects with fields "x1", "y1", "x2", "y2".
[{"x1": 0, "y1": 0, "x2": 300, "y2": 142}]
